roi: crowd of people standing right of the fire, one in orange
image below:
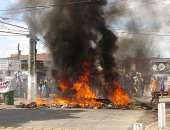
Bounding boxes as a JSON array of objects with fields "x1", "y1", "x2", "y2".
[{"x1": 120, "y1": 72, "x2": 170, "y2": 104}]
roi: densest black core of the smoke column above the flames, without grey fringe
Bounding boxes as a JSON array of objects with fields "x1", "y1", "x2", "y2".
[{"x1": 45, "y1": 0, "x2": 117, "y2": 80}]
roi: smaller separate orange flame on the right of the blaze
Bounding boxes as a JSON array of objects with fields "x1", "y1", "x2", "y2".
[{"x1": 108, "y1": 81, "x2": 130, "y2": 106}]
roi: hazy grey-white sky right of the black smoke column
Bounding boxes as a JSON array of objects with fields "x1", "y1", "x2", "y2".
[{"x1": 114, "y1": 0, "x2": 170, "y2": 58}]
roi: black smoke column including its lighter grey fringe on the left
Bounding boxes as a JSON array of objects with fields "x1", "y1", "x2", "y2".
[{"x1": 13, "y1": 0, "x2": 120, "y2": 81}]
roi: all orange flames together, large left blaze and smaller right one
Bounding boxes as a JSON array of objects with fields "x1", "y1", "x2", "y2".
[{"x1": 35, "y1": 62, "x2": 130, "y2": 108}]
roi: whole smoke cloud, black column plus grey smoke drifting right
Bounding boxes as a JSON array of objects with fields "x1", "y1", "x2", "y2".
[{"x1": 10, "y1": 0, "x2": 159, "y2": 77}]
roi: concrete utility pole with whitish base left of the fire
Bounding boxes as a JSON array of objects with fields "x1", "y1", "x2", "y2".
[{"x1": 27, "y1": 33, "x2": 37, "y2": 101}]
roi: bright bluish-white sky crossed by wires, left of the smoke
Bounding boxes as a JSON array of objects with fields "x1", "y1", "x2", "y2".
[{"x1": 0, "y1": 0, "x2": 47, "y2": 58}]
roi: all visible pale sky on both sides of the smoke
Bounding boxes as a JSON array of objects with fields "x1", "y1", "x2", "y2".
[{"x1": 0, "y1": 0, "x2": 170, "y2": 57}]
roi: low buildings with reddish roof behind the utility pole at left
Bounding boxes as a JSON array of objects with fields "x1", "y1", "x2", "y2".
[{"x1": 0, "y1": 53, "x2": 50, "y2": 98}]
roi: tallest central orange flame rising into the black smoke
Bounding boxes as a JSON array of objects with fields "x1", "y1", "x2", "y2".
[{"x1": 71, "y1": 62, "x2": 102, "y2": 107}]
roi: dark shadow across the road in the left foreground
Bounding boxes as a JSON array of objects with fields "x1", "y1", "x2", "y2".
[{"x1": 0, "y1": 109, "x2": 84, "y2": 127}]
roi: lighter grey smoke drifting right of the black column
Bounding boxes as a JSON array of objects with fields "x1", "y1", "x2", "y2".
[{"x1": 116, "y1": 0, "x2": 161, "y2": 60}]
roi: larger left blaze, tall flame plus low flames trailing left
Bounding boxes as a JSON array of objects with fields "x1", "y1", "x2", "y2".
[{"x1": 35, "y1": 62, "x2": 102, "y2": 108}]
